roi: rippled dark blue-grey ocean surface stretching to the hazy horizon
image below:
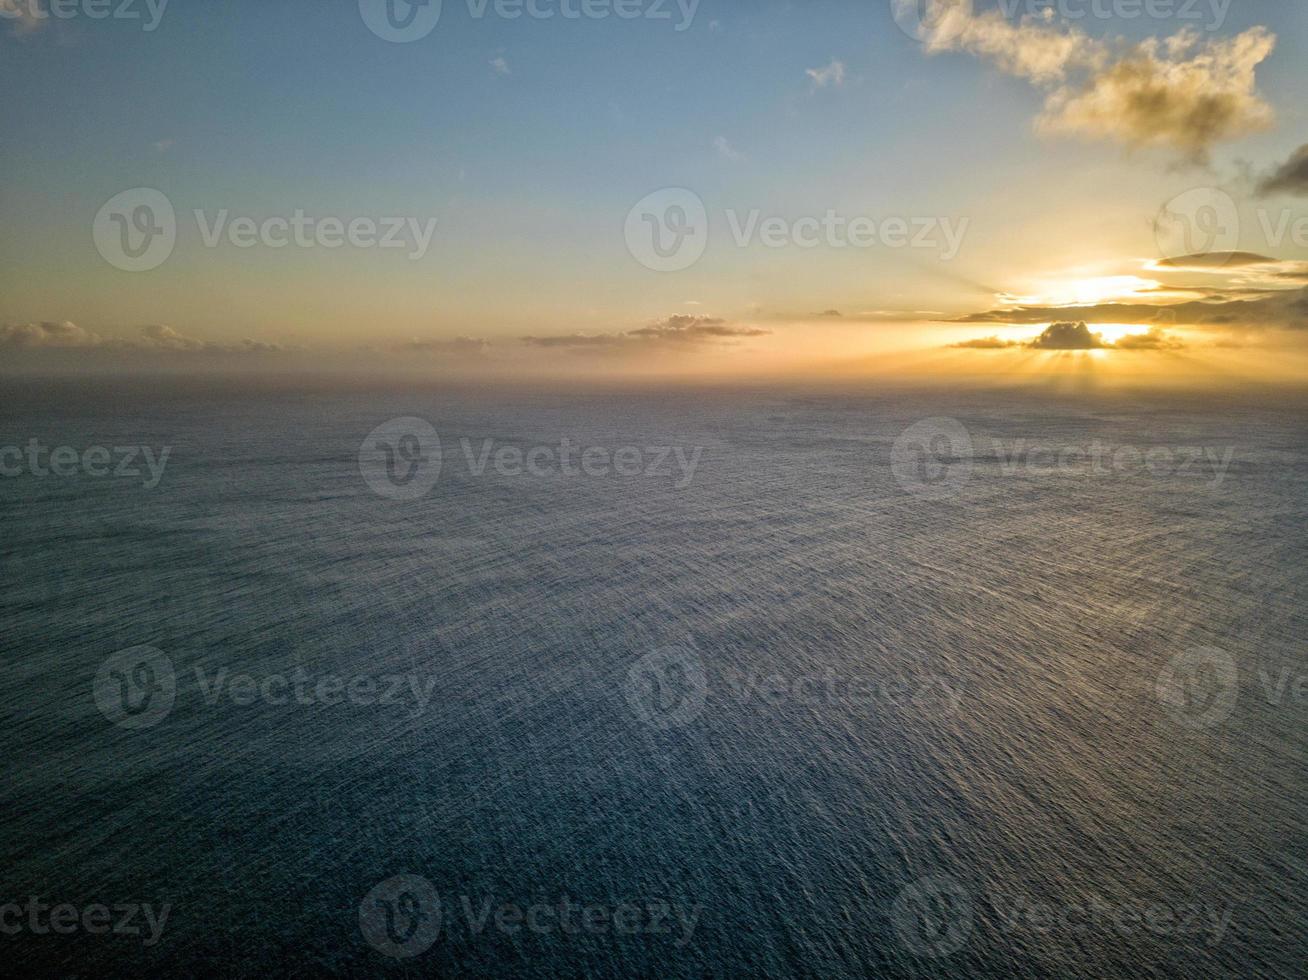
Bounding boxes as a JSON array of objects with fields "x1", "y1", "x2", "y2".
[{"x1": 0, "y1": 381, "x2": 1308, "y2": 977}]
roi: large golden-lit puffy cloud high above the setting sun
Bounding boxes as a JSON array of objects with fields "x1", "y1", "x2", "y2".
[{"x1": 895, "y1": 0, "x2": 1277, "y2": 162}]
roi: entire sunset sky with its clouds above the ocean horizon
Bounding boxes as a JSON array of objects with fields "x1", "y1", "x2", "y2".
[{"x1": 0, "y1": 0, "x2": 1308, "y2": 379}]
